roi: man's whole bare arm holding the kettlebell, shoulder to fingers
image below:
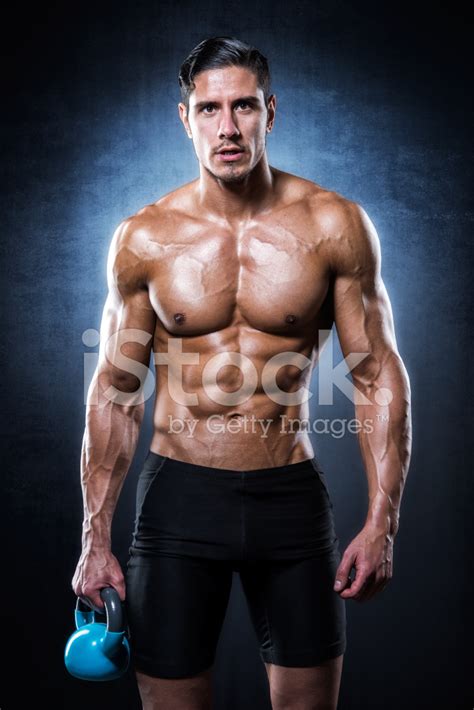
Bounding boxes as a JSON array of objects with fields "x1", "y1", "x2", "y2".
[{"x1": 72, "y1": 220, "x2": 156, "y2": 609}]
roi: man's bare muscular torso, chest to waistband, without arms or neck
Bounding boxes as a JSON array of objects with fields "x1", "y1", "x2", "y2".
[{"x1": 118, "y1": 168, "x2": 345, "y2": 470}]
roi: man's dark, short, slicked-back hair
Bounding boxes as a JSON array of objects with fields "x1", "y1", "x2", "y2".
[{"x1": 178, "y1": 37, "x2": 270, "y2": 109}]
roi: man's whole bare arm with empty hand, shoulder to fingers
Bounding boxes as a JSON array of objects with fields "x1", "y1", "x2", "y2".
[{"x1": 332, "y1": 202, "x2": 411, "y2": 600}]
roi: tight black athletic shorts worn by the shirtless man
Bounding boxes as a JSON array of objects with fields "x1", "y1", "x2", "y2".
[{"x1": 126, "y1": 451, "x2": 346, "y2": 678}]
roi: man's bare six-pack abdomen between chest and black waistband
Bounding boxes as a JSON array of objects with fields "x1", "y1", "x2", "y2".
[{"x1": 150, "y1": 304, "x2": 326, "y2": 471}]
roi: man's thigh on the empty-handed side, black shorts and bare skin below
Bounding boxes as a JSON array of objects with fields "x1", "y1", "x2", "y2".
[{"x1": 239, "y1": 560, "x2": 346, "y2": 710}]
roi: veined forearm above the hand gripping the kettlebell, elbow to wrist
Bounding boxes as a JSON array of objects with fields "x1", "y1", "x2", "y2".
[{"x1": 81, "y1": 376, "x2": 145, "y2": 550}]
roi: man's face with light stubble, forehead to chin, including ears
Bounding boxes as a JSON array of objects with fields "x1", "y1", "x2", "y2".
[{"x1": 179, "y1": 67, "x2": 275, "y2": 182}]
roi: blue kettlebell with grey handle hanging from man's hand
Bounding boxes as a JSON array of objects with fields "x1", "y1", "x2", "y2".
[{"x1": 64, "y1": 587, "x2": 130, "y2": 680}]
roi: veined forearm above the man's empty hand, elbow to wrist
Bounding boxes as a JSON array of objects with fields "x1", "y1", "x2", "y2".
[{"x1": 353, "y1": 352, "x2": 412, "y2": 535}]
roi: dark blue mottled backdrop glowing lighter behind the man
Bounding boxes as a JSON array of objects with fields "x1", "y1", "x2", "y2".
[{"x1": 0, "y1": 0, "x2": 473, "y2": 710}]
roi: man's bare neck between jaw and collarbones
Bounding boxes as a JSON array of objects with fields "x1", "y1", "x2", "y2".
[{"x1": 197, "y1": 154, "x2": 275, "y2": 222}]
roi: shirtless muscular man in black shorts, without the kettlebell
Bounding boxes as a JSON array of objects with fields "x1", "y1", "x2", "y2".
[{"x1": 73, "y1": 37, "x2": 411, "y2": 710}]
